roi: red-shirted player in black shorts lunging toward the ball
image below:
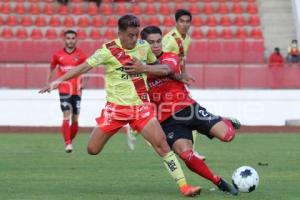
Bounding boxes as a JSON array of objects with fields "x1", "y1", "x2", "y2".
[{"x1": 134, "y1": 26, "x2": 239, "y2": 195}]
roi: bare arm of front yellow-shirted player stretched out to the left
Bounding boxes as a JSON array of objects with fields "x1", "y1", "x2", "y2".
[{"x1": 39, "y1": 62, "x2": 93, "y2": 93}]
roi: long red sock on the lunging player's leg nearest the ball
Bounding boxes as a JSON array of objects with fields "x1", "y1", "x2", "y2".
[{"x1": 180, "y1": 150, "x2": 220, "y2": 184}]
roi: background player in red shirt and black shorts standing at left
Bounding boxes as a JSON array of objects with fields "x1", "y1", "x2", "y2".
[{"x1": 47, "y1": 30, "x2": 86, "y2": 153}]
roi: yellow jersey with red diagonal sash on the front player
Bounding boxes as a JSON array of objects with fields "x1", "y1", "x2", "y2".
[{"x1": 87, "y1": 39, "x2": 156, "y2": 106}]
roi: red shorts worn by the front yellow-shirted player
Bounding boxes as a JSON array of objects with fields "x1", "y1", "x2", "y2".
[{"x1": 96, "y1": 102, "x2": 155, "y2": 134}]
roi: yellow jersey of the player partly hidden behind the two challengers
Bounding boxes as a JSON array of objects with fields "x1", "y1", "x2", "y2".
[{"x1": 162, "y1": 28, "x2": 191, "y2": 58}]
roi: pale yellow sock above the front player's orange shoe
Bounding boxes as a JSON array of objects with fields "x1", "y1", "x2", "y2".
[{"x1": 163, "y1": 151, "x2": 187, "y2": 187}]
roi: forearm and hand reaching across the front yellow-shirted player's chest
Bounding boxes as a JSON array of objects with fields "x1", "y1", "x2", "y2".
[{"x1": 124, "y1": 58, "x2": 172, "y2": 76}]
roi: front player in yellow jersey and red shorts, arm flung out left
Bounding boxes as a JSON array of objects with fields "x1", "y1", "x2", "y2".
[{"x1": 40, "y1": 15, "x2": 201, "y2": 196}]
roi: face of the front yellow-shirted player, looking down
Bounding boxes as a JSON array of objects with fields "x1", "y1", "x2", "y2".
[{"x1": 119, "y1": 27, "x2": 140, "y2": 49}]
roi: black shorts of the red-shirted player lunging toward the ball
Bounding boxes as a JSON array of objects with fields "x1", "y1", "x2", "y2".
[{"x1": 161, "y1": 103, "x2": 222, "y2": 147}]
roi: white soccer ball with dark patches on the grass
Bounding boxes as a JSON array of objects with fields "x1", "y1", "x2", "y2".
[{"x1": 232, "y1": 166, "x2": 259, "y2": 192}]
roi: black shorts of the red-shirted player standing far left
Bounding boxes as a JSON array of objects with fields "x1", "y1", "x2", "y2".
[{"x1": 59, "y1": 93, "x2": 81, "y2": 115}]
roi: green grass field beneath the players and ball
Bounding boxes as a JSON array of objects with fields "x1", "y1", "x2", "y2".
[{"x1": 0, "y1": 134, "x2": 300, "y2": 200}]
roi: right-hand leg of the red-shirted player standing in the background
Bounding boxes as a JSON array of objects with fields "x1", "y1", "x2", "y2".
[{"x1": 70, "y1": 95, "x2": 81, "y2": 140}]
